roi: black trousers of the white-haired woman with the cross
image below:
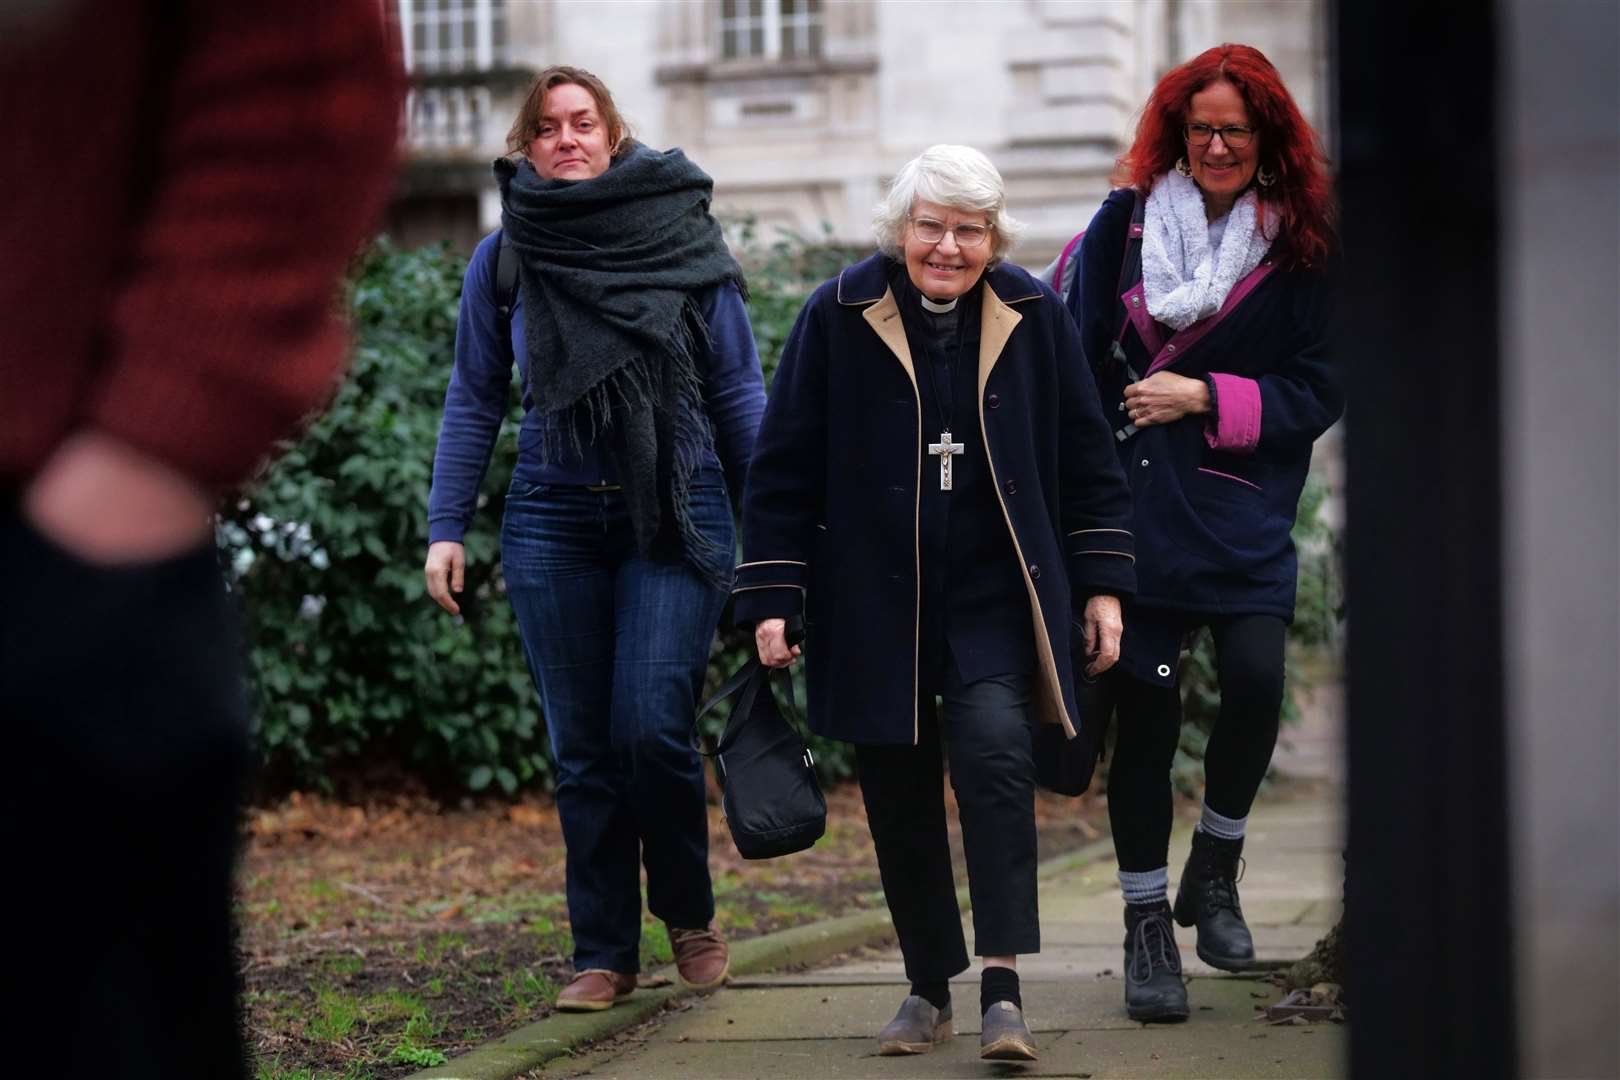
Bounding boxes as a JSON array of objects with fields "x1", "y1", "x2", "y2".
[{"x1": 855, "y1": 664, "x2": 1040, "y2": 983}]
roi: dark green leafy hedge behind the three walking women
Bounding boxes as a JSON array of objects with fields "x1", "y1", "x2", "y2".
[{"x1": 219, "y1": 222, "x2": 1337, "y2": 793}]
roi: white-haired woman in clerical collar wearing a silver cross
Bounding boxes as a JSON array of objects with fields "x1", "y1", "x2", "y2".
[{"x1": 734, "y1": 146, "x2": 1136, "y2": 1061}]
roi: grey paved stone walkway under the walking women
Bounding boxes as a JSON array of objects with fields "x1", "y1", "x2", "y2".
[{"x1": 527, "y1": 787, "x2": 1345, "y2": 1080}]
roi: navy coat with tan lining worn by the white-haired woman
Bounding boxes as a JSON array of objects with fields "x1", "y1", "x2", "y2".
[{"x1": 734, "y1": 254, "x2": 1136, "y2": 743}]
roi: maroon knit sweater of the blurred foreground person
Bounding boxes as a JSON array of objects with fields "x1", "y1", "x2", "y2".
[{"x1": 0, "y1": 0, "x2": 400, "y2": 491}]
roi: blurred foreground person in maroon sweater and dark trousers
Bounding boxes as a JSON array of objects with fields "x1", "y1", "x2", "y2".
[{"x1": 0, "y1": 0, "x2": 399, "y2": 1080}]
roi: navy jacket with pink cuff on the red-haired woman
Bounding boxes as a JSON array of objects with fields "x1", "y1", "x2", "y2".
[{"x1": 1069, "y1": 189, "x2": 1343, "y2": 625}]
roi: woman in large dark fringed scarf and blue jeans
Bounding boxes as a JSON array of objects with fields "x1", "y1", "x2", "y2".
[{"x1": 426, "y1": 66, "x2": 765, "y2": 1010}]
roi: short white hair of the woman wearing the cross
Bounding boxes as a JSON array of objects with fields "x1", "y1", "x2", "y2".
[{"x1": 872, "y1": 142, "x2": 1024, "y2": 267}]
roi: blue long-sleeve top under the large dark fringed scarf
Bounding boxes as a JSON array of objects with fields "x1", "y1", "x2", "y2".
[{"x1": 428, "y1": 230, "x2": 765, "y2": 542}]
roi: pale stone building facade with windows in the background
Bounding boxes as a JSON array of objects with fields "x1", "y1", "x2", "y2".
[{"x1": 390, "y1": 0, "x2": 1332, "y2": 264}]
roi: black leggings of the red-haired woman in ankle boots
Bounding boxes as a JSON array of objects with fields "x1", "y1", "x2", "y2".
[{"x1": 1108, "y1": 615, "x2": 1288, "y2": 873}]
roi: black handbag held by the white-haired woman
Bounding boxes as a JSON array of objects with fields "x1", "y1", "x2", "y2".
[{"x1": 692, "y1": 659, "x2": 826, "y2": 858}]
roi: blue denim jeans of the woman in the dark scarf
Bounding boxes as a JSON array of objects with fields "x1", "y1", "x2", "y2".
[{"x1": 501, "y1": 470, "x2": 734, "y2": 972}]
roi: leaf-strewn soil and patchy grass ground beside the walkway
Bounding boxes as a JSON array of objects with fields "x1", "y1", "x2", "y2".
[{"x1": 237, "y1": 784, "x2": 1106, "y2": 1080}]
